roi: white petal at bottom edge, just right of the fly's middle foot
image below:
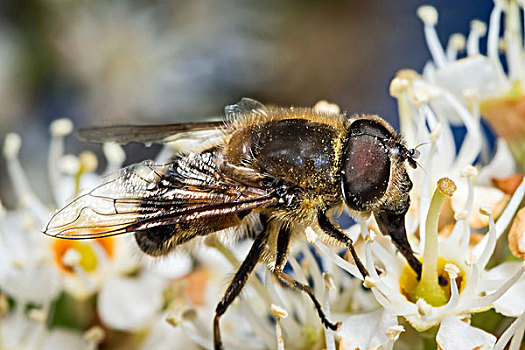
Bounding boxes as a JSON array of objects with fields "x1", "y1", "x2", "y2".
[{"x1": 337, "y1": 308, "x2": 397, "y2": 350}]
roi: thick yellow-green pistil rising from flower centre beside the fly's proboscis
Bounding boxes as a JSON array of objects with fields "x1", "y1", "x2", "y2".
[{"x1": 415, "y1": 178, "x2": 456, "y2": 306}]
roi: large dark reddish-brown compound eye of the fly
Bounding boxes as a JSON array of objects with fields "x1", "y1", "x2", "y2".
[{"x1": 341, "y1": 135, "x2": 390, "y2": 211}]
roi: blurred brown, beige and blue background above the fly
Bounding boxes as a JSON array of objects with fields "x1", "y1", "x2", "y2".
[{"x1": 0, "y1": 0, "x2": 492, "y2": 207}]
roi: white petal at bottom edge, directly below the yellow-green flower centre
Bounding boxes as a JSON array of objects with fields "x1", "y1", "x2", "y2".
[{"x1": 436, "y1": 316, "x2": 496, "y2": 350}]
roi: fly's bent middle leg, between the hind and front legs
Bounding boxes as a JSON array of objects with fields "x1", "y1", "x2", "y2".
[{"x1": 273, "y1": 226, "x2": 340, "y2": 331}]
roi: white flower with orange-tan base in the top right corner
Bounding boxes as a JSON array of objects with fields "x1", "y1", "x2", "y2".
[{"x1": 418, "y1": 0, "x2": 525, "y2": 165}]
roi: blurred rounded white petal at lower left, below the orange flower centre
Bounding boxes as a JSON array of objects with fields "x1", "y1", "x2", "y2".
[{"x1": 97, "y1": 276, "x2": 163, "y2": 331}]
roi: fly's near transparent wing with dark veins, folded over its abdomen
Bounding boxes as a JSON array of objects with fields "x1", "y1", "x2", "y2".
[{"x1": 44, "y1": 152, "x2": 277, "y2": 239}]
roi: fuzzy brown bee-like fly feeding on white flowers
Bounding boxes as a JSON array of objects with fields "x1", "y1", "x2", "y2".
[{"x1": 44, "y1": 99, "x2": 421, "y2": 349}]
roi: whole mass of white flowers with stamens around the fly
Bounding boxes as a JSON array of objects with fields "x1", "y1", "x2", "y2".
[{"x1": 0, "y1": 1, "x2": 525, "y2": 350}]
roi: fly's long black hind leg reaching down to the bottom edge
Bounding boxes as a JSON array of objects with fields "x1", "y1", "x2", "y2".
[{"x1": 213, "y1": 230, "x2": 267, "y2": 350}]
